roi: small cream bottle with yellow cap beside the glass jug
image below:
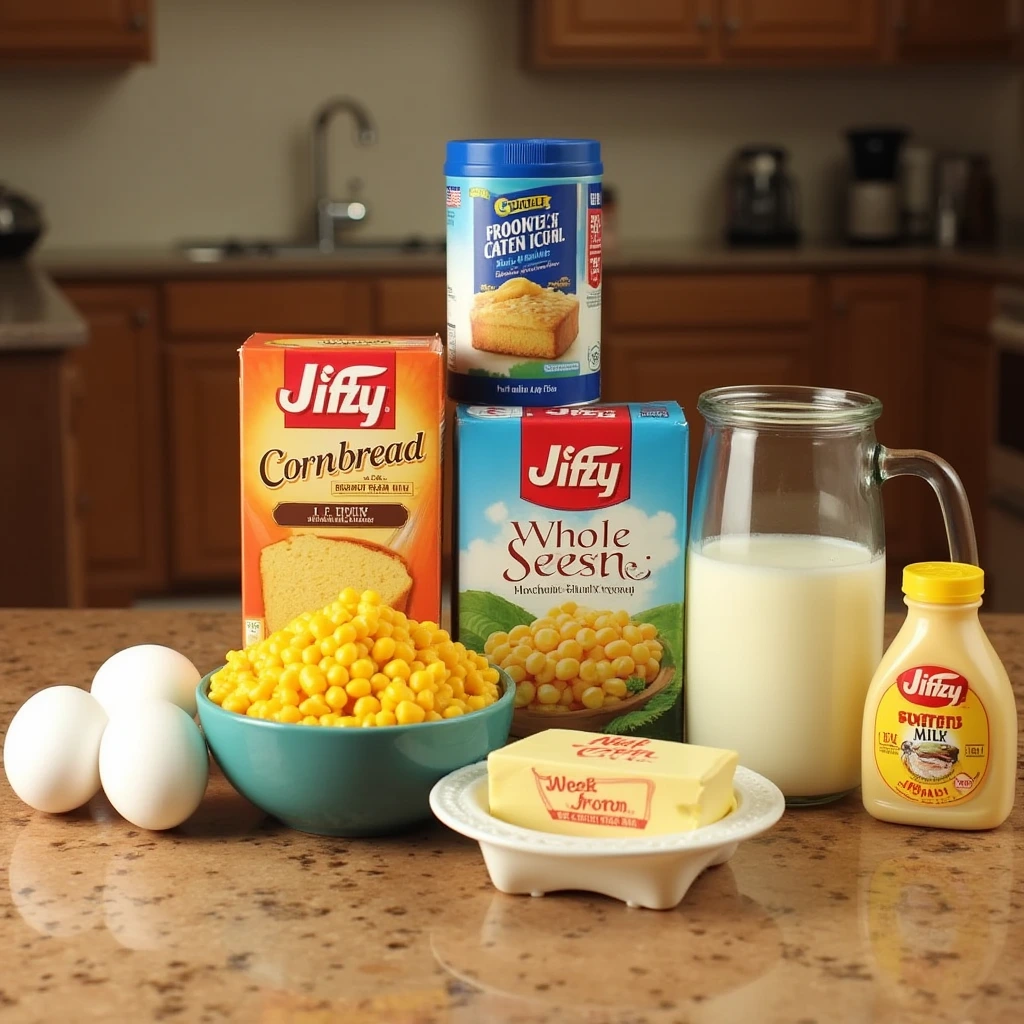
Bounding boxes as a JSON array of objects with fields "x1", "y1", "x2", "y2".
[{"x1": 860, "y1": 562, "x2": 1017, "y2": 828}]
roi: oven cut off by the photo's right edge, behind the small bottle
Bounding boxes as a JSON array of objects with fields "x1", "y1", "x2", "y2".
[{"x1": 985, "y1": 288, "x2": 1024, "y2": 611}]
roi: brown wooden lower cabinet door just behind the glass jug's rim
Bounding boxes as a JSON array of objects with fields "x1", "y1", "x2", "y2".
[{"x1": 602, "y1": 331, "x2": 811, "y2": 495}]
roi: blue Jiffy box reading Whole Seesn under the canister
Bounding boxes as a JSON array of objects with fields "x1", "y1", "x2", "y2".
[{"x1": 453, "y1": 402, "x2": 688, "y2": 739}]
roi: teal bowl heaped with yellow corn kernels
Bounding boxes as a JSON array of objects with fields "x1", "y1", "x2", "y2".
[{"x1": 198, "y1": 589, "x2": 515, "y2": 836}]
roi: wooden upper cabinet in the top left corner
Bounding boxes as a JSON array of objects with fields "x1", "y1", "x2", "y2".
[{"x1": 0, "y1": 0, "x2": 153, "y2": 66}]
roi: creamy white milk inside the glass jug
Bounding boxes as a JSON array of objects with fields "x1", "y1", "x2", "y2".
[{"x1": 685, "y1": 534, "x2": 886, "y2": 799}]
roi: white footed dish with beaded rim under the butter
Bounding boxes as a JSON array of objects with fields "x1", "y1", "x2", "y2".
[{"x1": 430, "y1": 762, "x2": 785, "y2": 910}]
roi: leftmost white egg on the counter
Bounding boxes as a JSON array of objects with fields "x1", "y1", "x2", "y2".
[{"x1": 3, "y1": 686, "x2": 106, "y2": 814}]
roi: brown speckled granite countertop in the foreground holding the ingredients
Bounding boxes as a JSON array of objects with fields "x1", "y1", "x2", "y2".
[{"x1": 0, "y1": 610, "x2": 1024, "y2": 1024}]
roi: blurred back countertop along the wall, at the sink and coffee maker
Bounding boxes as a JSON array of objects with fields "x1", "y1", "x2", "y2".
[{"x1": 36, "y1": 243, "x2": 1024, "y2": 280}]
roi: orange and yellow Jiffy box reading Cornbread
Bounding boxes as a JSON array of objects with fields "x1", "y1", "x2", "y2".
[{"x1": 240, "y1": 334, "x2": 444, "y2": 643}]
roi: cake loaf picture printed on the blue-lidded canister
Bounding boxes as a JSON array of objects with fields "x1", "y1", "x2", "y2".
[{"x1": 469, "y1": 278, "x2": 580, "y2": 359}]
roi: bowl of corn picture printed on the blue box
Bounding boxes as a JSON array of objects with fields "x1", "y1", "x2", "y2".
[{"x1": 483, "y1": 601, "x2": 676, "y2": 736}]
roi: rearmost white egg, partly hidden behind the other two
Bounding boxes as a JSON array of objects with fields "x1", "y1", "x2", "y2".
[{"x1": 91, "y1": 643, "x2": 202, "y2": 715}]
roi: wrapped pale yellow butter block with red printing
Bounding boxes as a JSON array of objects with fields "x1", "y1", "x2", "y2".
[{"x1": 487, "y1": 729, "x2": 738, "y2": 836}]
